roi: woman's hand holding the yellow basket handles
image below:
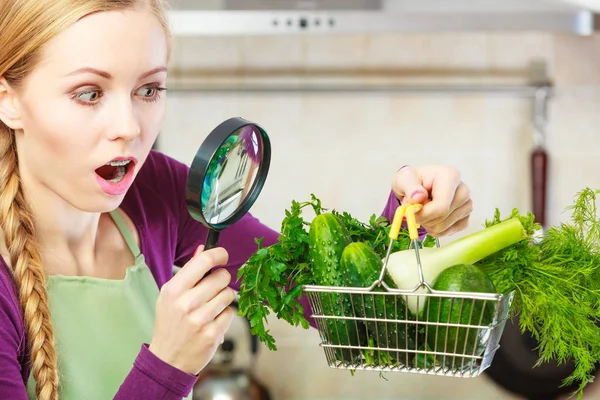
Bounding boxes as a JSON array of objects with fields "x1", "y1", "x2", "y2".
[{"x1": 392, "y1": 165, "x2": 473, "y2": 237}]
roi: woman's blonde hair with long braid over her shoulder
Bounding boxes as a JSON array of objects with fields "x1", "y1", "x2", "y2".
[{"x1": 0, "y1": 0, "x2": 170, "y2": 400}]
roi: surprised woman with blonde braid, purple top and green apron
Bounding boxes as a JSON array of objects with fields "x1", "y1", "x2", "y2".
[{"x1": 0, "y1": 0, "x2": 472, "y2": 400}]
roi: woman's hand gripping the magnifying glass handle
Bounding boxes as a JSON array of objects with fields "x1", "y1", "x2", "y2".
[{"x1": 149, "y1": 248, "x2": 235, "y2": 375}]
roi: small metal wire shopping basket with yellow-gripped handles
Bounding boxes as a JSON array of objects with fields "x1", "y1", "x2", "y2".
[{"x1": 303, "y1": 205, "x2": 513, "y2": 378}]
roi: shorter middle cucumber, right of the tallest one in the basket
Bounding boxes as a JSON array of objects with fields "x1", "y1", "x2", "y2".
[{"x1": 340, "y1": 242, "x2": 416, "y2": 365}]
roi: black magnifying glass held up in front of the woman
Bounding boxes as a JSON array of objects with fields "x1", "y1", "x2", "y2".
[{"x1": 186, "y1": 117, "x2": 271, "y2": 250}]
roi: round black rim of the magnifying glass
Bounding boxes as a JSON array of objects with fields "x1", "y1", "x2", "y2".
[{"x1": 186, "y1": 117, "x2": 271, "y2": 231}]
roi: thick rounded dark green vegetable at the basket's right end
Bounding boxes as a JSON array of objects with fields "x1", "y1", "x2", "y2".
[{"x1": 425, "y1": 264, "x2": 496, "y2": 369}]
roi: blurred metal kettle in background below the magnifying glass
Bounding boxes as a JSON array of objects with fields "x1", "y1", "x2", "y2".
[{"x1": 192, "y1": 302, "x2": 271, "y2": 400}]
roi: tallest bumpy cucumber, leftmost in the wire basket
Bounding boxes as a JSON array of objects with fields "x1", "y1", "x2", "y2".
[{"x1": 308, "y1": 213, "x2": 365, "y2": 363}]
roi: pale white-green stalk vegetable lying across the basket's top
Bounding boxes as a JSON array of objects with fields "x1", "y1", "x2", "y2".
[{"x1": 388, "y1": 218, "x2": 527, "y2": 315}]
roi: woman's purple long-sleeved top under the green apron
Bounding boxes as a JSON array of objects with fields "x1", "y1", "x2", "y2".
[{"x1": 0, "y1": 151, "x2": 398, "y2": 400}]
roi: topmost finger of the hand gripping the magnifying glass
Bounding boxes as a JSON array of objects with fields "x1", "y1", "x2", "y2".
[{"x1": 163, "y1": 247, "x2": 229, "y2": 293}]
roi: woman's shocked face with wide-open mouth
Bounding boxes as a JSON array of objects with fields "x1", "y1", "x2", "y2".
[{"x1": 10, "y1": 9, "x2": 167, "y2": 212}]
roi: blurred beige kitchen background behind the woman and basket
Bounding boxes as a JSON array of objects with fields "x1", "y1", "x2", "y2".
[{"x1": 156, "y1": 0, "x2": 600, "y2": 400}]
